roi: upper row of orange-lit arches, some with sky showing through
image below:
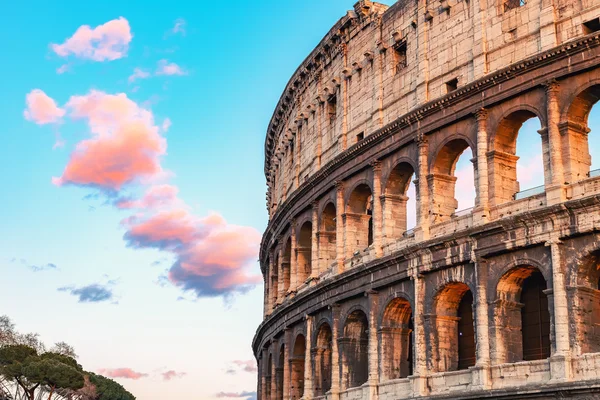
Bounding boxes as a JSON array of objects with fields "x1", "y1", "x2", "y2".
[{"x1": 266, "y1": 84, "x2": 600, "y2": 308}]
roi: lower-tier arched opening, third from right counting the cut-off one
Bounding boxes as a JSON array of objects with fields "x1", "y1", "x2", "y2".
[{"x1": 432, "y1": 282, "x2": 476, "y2": 372}]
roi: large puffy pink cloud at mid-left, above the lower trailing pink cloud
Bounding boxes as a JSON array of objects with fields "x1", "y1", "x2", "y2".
[{"x1": 53, "y1": 91, "x2": 166, "y2": 191}]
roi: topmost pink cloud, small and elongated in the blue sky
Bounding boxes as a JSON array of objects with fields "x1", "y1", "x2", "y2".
[{"x1": 50, "y1": 17, "x2": 132, "y2": 61}]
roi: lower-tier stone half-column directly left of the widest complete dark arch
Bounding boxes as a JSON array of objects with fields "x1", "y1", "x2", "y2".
[{"x1": 471, "y1": 252, "x2": 492, "y2": 390}]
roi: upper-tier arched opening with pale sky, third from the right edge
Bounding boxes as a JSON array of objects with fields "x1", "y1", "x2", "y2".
[{"x1": 427, "y1": 139, "x2": 475, "y2": 223}]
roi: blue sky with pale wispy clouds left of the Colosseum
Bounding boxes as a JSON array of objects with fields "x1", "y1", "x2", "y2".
[{"x1": 0, "y1": 0, "x2": 600, "y2": 400}]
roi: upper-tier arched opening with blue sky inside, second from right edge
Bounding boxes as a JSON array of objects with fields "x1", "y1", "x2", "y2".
[{"x1": 488, "y1": 110, "x2": 550, "y2": 204}]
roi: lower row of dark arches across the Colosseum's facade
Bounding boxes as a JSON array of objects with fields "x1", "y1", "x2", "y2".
[{"x1": 260, "y1": 250, "x2": 600, "y2": 400}]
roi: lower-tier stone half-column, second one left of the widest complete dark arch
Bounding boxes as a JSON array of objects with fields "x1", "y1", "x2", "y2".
[{"x1": 409, "y1": 257, "x2": 428, "y2": 396}]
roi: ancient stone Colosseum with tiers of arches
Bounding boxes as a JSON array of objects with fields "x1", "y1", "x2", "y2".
[{"x1": 253, "y1": 0, "x2": 600, "y2": 400}]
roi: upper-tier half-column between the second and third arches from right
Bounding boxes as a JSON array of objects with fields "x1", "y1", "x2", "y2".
[{"x1": 473, "y1": 108, "x2": 490, "y2": 224}]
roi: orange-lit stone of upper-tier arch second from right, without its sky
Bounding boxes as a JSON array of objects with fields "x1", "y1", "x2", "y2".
[{"x1": 487, "y1": 105, "x2": 551, "y2": 204}]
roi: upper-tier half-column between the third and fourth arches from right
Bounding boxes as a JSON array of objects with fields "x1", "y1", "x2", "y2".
[{"x1": 415, "y1": 133, "x2": 429, "y2": 241}]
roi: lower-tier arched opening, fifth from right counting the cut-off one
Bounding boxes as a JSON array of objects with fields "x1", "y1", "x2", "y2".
[{"x1": 340, "y1": 310, "x2": 369, "y2": 390}]
